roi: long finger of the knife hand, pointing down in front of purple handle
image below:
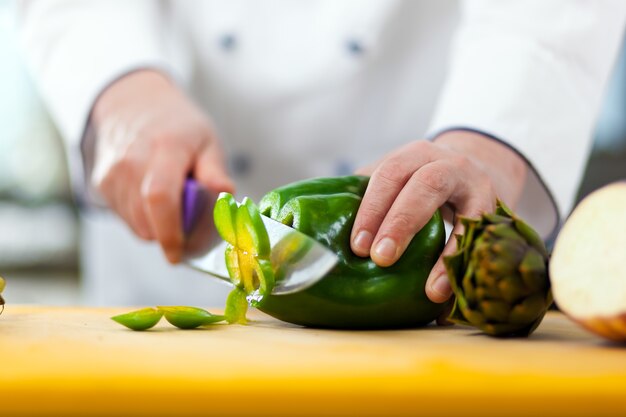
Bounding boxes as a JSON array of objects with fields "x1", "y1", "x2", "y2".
[{"x1": 141, "y1": 148, "x2": 193, "y2": 263}]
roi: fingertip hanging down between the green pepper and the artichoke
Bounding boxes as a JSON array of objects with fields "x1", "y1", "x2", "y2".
[{"x1": 426, "y1": 195, "x2": 495, "y2": 303}]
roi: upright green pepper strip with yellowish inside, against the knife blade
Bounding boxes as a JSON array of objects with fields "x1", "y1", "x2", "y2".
[{"x1": 213, "y1": 193, "x2": 274, "y2": 323}]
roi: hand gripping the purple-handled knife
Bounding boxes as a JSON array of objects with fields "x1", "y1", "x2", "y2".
[{"x1": 91, "y1": 70, "x2": 234, "y2": 263}]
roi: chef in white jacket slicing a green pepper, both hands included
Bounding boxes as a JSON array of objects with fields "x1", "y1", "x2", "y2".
[{"x1": 20, "y1": 0, "x2": 626, "y2": 305}]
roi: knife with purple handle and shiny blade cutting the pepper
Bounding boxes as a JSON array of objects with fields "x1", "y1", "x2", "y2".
[{"x1": 182, "y1": 178, "x2": 338, "y2": 295}]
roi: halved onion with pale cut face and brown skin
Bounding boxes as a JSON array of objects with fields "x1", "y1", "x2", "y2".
[{"x1": 550, "y1": 181, "x2": 626, "y2": 342}]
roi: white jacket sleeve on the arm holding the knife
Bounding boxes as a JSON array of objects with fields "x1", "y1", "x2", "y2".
[{"x1": 18, "y1": 0, "x2": 186, "y2": 198}]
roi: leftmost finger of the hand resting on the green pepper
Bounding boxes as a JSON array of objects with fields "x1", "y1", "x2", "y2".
[{"x1": 350, "y1": 142, "x2": 430, "y2": 257}]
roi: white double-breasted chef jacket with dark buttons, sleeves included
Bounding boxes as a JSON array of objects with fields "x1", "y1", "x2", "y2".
[{"x1": 21, "y1": 0, "x2": 626, "y2": 305}]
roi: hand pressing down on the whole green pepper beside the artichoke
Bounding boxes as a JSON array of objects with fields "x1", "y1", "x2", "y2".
[{"x1": 351, "y1": 131, "x2": 527, "y2": 303}]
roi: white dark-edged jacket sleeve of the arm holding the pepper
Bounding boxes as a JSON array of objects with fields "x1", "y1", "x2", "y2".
[{"x1": 429, "y1": 0, "x2": 626, "y2": 237}]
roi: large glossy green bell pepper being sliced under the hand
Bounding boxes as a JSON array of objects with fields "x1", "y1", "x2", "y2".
[{"x1": 256, "y1": 176, "x2": 445, "y2": 329}]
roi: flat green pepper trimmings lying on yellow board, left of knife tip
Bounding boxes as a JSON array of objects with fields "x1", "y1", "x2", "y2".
[{"x1": 111, "y1": 306, "x2": 225, "y2": 330}]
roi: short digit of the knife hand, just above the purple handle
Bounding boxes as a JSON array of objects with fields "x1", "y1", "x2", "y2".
[{"x1": 194, "y1": 141, "x2": 235, "y2": 193}]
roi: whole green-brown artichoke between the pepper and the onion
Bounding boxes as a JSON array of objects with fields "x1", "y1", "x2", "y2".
[{"x1": 444, "y1": 201, "x2": 552, "y2": 336}]
